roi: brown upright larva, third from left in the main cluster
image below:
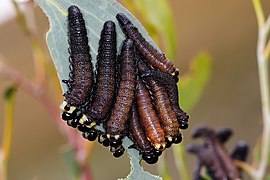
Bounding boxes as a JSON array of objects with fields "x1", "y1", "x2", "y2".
[{"x1": 106, "y1": 39, "x2": 136, "y2": 147}]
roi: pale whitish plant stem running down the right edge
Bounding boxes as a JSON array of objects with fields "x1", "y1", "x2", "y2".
[{"x1": 251, "y1": 0, "x2": 270, "y2": 180}]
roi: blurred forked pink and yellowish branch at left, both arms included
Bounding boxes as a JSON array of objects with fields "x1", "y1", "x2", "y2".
[{"x1": 4, "y1": 0, "x2": 93, "y2": 179}]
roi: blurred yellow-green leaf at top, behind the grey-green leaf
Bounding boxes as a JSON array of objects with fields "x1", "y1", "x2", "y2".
[{"x1": 123, "y1": 0, "x2": 176, "y2": 61}]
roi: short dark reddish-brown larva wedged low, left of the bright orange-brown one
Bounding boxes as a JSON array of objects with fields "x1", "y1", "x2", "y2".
[{"x1": 129, "y1": 103, "x2": 158, "y2": 164}]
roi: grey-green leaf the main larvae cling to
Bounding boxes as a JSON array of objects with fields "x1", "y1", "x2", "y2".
[{"x1": 36, "y1": 0, "x2": 163, "y2": 179}]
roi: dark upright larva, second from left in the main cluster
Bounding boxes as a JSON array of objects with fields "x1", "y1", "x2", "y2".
[{"x1": 83, "y1": 21, "x2": 117, "y2": 124}]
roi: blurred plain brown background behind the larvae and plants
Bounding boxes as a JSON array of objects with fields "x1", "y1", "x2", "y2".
[{"x1": 0, "y1": 0, "x2": 270, "y2": 180}]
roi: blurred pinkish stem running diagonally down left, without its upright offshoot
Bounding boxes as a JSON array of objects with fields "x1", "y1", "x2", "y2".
[{"x1": 0, "y1": 53, "x2": 92, "y2": 177}]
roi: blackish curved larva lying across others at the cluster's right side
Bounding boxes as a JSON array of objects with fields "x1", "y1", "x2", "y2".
[{"x1": 141, "y1": 70, "x2": 189, "y2": 129}]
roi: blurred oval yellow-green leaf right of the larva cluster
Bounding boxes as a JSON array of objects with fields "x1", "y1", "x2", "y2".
[{"x1": 178, "y1": 52, "x2": 212, "y2": 111}]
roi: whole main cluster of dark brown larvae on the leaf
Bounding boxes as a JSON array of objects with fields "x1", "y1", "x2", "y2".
[{"x1": 60, "y1": 6, "x2": 189, "y2": 164}]
